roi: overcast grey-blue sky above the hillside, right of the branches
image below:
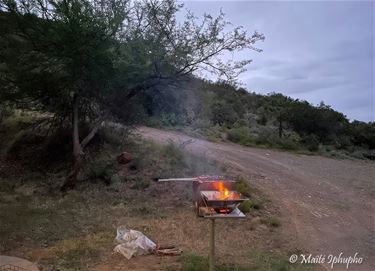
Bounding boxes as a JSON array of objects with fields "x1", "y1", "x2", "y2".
[{"x1": 183, "y1": 1, "x2": 375, "y2": 121}]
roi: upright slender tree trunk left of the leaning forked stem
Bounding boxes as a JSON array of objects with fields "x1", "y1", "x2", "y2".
[{"x1": 61, "y1": 96, "x2": 83, "y2": 191}]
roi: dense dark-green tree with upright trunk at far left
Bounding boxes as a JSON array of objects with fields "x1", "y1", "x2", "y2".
[{"x1": 1, "y1": 0, "x2": 127, "y2": 190}]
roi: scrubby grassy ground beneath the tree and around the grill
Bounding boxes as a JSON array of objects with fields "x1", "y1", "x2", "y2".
[{"x1": 0, "y1": 112, "x2": 310, "y2": 271}]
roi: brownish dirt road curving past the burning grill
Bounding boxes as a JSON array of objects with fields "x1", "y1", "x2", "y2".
[{"x1": 139, "y1": 127, "x2": 375, "y2": 270}]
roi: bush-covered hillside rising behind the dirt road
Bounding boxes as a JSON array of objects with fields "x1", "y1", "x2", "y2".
[{"x1": 136, "y1": 79, "x2": 375, "y2": 159}]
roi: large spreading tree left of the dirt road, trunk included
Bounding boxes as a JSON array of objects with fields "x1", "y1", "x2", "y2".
[{"x1": 0, "y1": 0, "x2": 264, "y2": 189}]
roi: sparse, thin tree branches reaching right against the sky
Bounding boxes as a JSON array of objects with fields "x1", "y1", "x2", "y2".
[{"x1": 122, "y1": 0, "x2": 264, "y2": 92}]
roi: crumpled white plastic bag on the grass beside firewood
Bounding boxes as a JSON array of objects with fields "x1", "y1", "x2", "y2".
[{"x1": 113, "y1": 226, "x2": 156, "y2": 260}]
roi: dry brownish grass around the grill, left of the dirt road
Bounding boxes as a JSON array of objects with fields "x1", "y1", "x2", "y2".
[{"x1": 0, "y1": 122, "x2": 310, "y2": 270}]
